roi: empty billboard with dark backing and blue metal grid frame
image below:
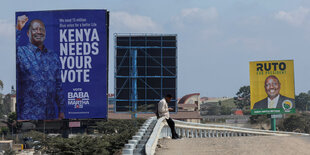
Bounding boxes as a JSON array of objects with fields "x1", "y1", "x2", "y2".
[{"x1": 114, "y1": 34, "x2": 177, "y2": 113}]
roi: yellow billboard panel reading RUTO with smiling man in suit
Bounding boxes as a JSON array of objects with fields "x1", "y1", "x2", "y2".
[{"x1": 250, "y1": 60, "x2": 295, "y2": 115}]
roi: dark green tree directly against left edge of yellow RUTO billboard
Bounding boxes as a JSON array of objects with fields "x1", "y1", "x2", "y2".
[{"x1": 234, "y1": 86, "x2": 251, "y2": 110}]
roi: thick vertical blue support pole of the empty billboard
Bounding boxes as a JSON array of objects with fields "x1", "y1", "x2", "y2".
[{"x1": 130, "y1": 49, "x2": 138, "y2": 118}]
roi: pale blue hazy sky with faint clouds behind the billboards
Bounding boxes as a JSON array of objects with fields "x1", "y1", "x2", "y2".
[{"x1": 0, "y1": 0, "x2": 310, "y2": 97}]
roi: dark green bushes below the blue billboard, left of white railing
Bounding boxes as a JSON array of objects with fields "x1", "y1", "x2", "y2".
[{"x1": 24, "y1": 119, "x2": 145, "y2": 155}]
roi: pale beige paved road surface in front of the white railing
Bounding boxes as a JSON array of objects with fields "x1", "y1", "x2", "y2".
[{"x1": 156, "y1": 136, "x2": 310, "y2": 155}]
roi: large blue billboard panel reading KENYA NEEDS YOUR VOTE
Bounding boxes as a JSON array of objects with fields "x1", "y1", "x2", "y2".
[{"x1": 15, "y1": 10, "x2": 109, "y2": 120}]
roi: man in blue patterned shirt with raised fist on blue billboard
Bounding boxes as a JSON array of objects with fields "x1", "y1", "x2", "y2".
[{"x1": 16, "y1": 15, "x2": 64, "y2": 120}]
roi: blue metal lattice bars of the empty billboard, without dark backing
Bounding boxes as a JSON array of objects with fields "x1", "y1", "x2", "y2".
[{"x1": 114, "y1": 34, "x2": 178, "y2": 114}]
